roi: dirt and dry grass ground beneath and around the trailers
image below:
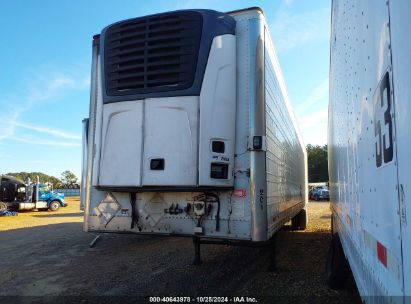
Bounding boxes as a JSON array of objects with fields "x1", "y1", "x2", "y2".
[{"x1": 0, "y1": 198, "x2": 361, "y2": 303}]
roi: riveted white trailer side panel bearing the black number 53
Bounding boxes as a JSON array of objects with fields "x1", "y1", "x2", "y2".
[{"x1": 328, "y1": 0, "x2": 403, "y2": 302}]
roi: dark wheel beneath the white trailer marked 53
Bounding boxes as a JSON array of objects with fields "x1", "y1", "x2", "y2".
[{"x1": 326, "y1": 233, "x2": 350, "y2": 289}]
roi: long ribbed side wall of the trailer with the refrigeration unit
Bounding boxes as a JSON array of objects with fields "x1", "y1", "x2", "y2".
[{"x1": 265, "y1": 28, "x2": 307, "y2": 236}]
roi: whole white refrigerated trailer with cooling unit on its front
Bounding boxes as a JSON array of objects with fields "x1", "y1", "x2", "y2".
[{"x1": 82, "y1": 8, "x2": 307, "y2": 262}]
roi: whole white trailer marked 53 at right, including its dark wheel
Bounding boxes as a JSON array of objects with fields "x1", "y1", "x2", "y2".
[{"x1": 328, "y1": 0, "x2": 411, "y2": 303}]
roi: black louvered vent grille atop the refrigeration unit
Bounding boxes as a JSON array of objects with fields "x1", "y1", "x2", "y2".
[{"x1": 104, "y1": 11, "x2": 203, "y2": 96}]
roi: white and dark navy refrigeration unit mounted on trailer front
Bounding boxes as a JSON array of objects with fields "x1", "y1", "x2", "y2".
[{"x1": 93, "y1": 10, "x2": 236, "y2": 191}]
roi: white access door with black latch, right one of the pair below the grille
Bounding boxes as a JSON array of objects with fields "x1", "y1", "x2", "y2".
[{"x1": 142, "y1": 96, "x2": 199, "y2": 187}]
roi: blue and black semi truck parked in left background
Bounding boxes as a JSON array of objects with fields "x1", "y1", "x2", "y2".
[{"x1": 0, "y1": 175, "x2": 67, "y2": 211}]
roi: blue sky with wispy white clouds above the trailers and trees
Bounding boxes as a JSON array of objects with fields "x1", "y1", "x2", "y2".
[{"x1": 0, "y1": 0, "x2": 331, "y2": 177}]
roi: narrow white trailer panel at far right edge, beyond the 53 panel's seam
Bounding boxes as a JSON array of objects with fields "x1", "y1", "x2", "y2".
[{"x1": 389, "y1": 0, "x2": 411, "y2": 296}]
